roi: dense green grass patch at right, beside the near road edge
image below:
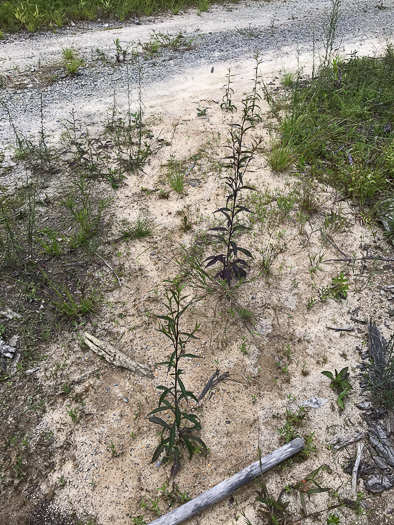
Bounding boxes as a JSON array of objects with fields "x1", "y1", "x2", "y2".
[{"x1": 276, "y1": 46, "x2": 394, "y2": 221}]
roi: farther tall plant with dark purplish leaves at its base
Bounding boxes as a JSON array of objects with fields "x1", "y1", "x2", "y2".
[{"x1": 204, "y1": 99, "x2": 260, "y2": 286}]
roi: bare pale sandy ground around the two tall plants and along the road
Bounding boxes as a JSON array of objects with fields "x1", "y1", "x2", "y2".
[{"x1": 0, "y1": 0, "x2": 394, "y2": 525}]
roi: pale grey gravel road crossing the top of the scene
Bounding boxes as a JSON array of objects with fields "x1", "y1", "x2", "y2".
[{"x1": 0, "y1": 0, "x2": 394, "y2": 144}]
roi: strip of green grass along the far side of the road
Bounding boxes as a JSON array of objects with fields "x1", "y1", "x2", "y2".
[{"x1": 0, "y1": 0, "x2": 223, "y2": 33}]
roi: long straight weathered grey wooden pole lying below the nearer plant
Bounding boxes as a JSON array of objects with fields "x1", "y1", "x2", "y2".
[{"x1": 150, "y1": 438, "x2": 305, "y2": 525}]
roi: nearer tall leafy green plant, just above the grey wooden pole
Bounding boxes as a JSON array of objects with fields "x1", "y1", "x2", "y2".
[{"x1": 149, "y1": 277, "x2": 207, "y2": 477}]
